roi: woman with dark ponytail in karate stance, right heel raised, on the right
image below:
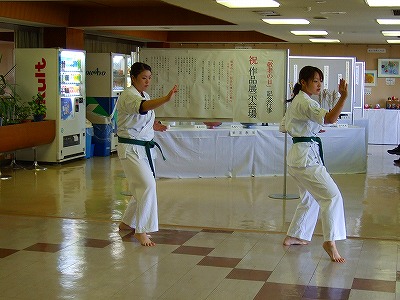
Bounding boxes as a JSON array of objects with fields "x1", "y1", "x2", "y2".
[{"x1": 280, "y1": 66, "x2": 347, "y2": 263}]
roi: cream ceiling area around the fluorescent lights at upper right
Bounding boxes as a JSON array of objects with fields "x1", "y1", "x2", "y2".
[{"x1": 159, "y1": 0, "x2": 400, "y2": 44}]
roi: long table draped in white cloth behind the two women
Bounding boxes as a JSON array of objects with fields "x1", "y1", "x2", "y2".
[{"x1": 154, "y1": 126, "x2": 367, "y2": 178}]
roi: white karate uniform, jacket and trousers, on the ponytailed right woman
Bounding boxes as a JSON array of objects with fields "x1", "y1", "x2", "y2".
[{"x1": 280, "y1": 91, "x2": 346, "y2": 241}]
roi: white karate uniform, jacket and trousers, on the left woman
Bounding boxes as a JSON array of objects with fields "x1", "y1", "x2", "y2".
[{"x1": 117, "y1": 86, "x2": 158, "y2": 233}]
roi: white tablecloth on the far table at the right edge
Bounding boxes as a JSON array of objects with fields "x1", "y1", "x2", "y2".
[{"x1": 364, "y1": 109, "x2": 400, "y2": 145}]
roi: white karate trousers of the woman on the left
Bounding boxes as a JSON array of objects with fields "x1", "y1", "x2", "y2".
[{"x1": 121, "y1": 152, "x2": 158, "y2": 233}]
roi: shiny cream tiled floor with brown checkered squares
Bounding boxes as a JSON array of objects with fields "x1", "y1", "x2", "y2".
[{"x1": 0, "y1": 145, "x2": 400, "y2": 300}]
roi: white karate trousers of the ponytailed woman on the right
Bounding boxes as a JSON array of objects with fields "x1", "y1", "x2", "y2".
[{"x1": 287, "y1": 165, "x2": 346, "y2": 241}]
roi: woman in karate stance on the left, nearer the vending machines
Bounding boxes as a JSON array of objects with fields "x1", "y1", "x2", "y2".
[{"x1": 117, "y1": 62, "x2": 178, "y2": 246}]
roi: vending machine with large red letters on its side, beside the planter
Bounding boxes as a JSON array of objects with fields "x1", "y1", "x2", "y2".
[{"x1": 15, "y1": 48, "x2": 86, "y2": 162}]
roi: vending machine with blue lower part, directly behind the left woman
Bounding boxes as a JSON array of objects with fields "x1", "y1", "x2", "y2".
[{"x1": 86, "y1": 53, "x2": 129, "y2": 156}]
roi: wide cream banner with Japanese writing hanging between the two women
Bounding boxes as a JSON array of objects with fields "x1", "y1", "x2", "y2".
[{"x1": 139, "y1": 48, "x2": 288, "y2": 123}]
